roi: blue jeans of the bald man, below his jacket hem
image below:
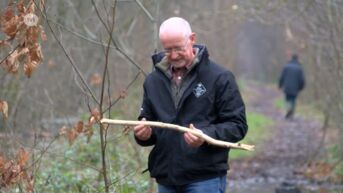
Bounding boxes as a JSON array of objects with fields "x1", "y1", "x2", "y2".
[{"x1": 158, "y1": 176, "x2": 226, "y2": 193}]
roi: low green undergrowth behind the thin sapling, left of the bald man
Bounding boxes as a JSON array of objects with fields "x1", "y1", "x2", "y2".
[{"x1": 35, "y1": 131, "x2": 149, "y2": 193}]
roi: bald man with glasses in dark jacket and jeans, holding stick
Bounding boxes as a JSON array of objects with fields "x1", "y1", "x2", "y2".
[{"x1": 134, "y1": 17, "x2": 248, "y2": 193}]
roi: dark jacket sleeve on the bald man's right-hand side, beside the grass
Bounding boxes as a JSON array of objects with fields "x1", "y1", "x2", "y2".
[{"x1": 203, "y1": 71, "x2": 248, "y2": 142}]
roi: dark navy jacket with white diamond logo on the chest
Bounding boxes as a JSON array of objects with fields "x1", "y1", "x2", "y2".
[{"x1": 136, "y1": 46, "x2": 248, "y2": 185}]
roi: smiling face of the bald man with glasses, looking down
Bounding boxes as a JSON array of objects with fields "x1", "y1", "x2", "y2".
[{"x1": 161, "y1": 34, "x2": 194, "y2": 68}]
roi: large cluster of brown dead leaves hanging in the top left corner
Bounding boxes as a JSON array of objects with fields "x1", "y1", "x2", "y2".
[{"x1": 0, "y1": 0, "x2": 47, "y2": 77}]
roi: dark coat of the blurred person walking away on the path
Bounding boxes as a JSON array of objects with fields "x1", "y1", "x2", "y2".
[{"x1": 279, "y1": 60, "x2": 305, "y2": 96}]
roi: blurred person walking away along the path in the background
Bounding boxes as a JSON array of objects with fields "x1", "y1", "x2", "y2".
[{"x1": 279, "y1": 54, "x2": 305, "y2": 119}]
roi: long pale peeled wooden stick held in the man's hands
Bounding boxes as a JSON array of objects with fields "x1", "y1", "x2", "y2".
[{"x1": 101, "y1": 119, "x2": 255, "y2": 151}]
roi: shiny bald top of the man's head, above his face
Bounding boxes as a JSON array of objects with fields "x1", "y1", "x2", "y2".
[{"x1": 159, "y1": 17, "x2": 192, "y2": 37}]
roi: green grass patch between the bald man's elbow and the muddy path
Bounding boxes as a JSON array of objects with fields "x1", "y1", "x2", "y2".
[{"x1": 230, "y1": 112, "x2": 273, "y2": 160}]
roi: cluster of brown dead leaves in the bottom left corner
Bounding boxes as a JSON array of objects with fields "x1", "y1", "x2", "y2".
[{"x1": 0, "y1": 148, "x2": 34, "y2": 192}]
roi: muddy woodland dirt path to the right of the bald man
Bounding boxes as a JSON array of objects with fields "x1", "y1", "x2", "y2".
[{"x1": 229, "y1": 84, "x2": 321, "y2": 183}]
